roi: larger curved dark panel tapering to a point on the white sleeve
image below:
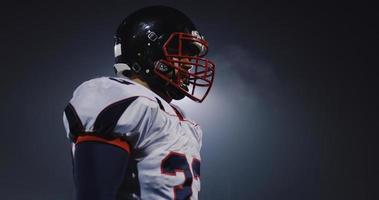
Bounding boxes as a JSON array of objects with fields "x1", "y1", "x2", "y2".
[{"x1": 93, "y1": 97, "x2": 138, "y2": 138}]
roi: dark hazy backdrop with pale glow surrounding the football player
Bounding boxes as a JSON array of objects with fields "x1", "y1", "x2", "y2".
[{"x1": 0, "y1": 0, "x2": 379, "y2": 200}]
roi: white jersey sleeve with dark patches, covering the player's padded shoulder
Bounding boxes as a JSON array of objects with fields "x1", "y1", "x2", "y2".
[{"x1": 63, "y1": 78, "x2": 159, "y2": 147}]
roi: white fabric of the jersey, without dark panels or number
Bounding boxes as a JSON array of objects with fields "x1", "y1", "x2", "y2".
[{"x1": 63, "y1": 77, "x2": 202, "y2": 200}]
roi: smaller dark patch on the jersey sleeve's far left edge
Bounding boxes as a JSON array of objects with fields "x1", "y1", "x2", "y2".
[{"x1": 64, "y1": 103, "x2": 84, "y2": 140}]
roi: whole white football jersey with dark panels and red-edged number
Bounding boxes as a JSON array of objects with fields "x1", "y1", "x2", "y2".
[{"x1": 63, "y1": 77, "x2": 202, "y2": 200}]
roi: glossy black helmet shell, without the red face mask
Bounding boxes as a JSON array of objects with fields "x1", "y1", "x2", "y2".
[{"x1": 115, "y1": 6, "x2": 196, "y2": 73}]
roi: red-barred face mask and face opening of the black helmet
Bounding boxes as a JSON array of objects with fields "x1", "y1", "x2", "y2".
[{"x1": 154, "y1": 31, "x2": 215, "y2": 102}]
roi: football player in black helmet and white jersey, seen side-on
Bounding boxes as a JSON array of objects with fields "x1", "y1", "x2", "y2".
[{"x1": 63, "y1": 6, "x2": 215, "y2": 200}]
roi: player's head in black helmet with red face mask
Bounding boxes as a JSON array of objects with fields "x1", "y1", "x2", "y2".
[{"x1": 115, "y1": 6, "x2": 215, "y2": 102}]
